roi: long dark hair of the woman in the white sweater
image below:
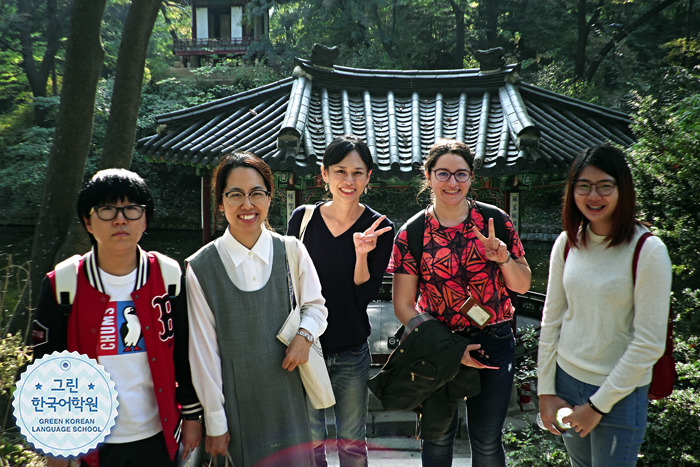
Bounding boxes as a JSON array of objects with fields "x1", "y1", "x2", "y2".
[{"x1": 562, "y1": 144, "x2": 639, "y2": 248}]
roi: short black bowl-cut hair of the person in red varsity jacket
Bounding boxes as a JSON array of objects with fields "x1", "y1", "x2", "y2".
[{"x1": 77, "y1": 169, "x2": 154, "y2": 245}]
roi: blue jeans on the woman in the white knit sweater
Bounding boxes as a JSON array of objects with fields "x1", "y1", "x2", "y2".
[{"x1": 556, "y1": 367, "x2": 649, "y2": 467}]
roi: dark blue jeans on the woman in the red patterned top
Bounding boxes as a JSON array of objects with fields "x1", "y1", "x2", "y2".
[{"x1": 422, "y1": 322, "x2": 515, "y2": 467}]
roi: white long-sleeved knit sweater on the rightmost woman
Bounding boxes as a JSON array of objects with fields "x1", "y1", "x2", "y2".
[{"x1": 537, "y1": 227, "x2": 671, "y2": 412}]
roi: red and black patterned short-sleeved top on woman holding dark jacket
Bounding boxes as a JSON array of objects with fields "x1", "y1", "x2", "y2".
[{"x1": 387, "y1": 206, "x2": 525, "y2": 331}]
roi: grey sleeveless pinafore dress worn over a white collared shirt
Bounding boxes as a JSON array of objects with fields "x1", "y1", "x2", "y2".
[{"x1": 189, "y1": 235, "x2": 315, "y2": 467}]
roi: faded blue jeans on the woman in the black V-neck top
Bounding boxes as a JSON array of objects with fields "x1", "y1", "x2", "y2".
[{"x1": 308, "y1": 342, "x2": 372, "y2": 467}]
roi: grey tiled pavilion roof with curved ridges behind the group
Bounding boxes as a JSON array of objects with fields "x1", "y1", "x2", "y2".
[{"x1": 136, "y1": 53, "x2": 634, "y2": 179}]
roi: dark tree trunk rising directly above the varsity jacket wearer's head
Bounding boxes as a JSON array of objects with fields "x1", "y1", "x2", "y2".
[{"x1": 100, "y1": 0, "x2": 162, "y2": 169}]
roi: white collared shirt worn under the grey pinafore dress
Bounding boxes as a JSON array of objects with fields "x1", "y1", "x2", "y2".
[{"x1": 186, "y1": 227, "x2": 328, "y2": 436}]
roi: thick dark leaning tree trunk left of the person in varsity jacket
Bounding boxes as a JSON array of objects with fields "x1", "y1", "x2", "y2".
[{"x1": 20, "y1": 0, "x2": 107, "y2": 336}]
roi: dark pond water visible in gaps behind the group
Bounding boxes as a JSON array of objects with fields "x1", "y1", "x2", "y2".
[{"x1": 0, "y1": 226, "x2": 552, "y2": 293}]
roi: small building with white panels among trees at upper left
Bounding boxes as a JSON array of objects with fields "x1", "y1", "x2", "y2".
[{"x1": 173, "y1": 0, "x2": 269, "y2": 68}]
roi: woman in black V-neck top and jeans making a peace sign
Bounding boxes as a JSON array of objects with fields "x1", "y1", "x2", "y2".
[{"x1": 287, "y1": 136, "x2": 394, "y2": 467}]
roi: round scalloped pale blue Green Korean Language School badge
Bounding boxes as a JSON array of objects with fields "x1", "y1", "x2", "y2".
[{"x1": 12, "y1": 351, "x2": 119, "y2": 457}]
